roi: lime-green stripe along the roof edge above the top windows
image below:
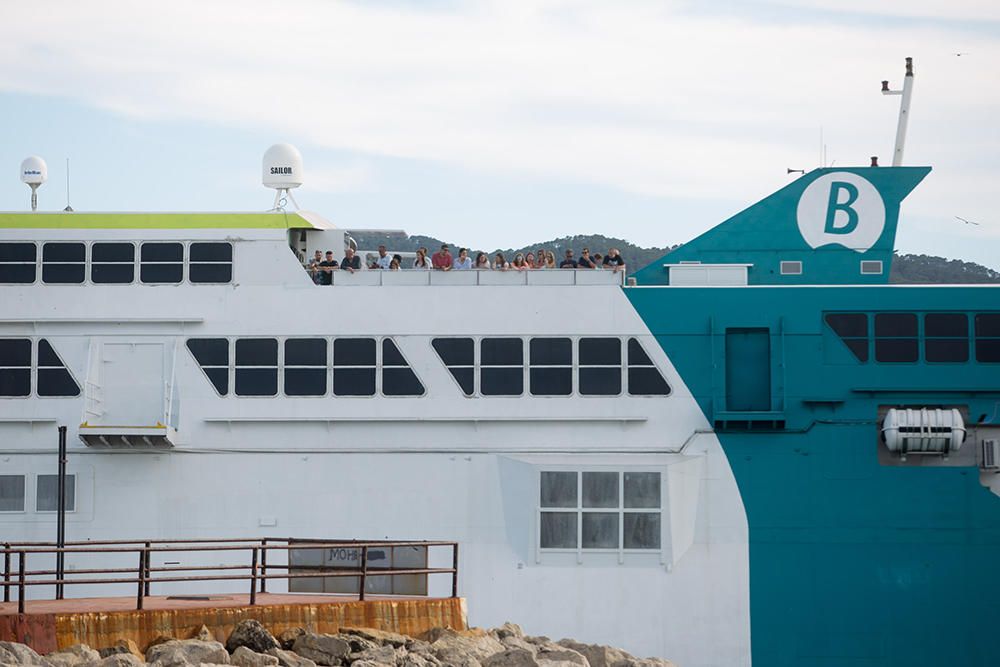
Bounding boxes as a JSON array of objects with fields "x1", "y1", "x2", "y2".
[{"x1": 0, "y1": 212, "x2": 315, "y2": 229}]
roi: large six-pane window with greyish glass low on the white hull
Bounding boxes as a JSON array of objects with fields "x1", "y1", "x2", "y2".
[{"x1": 538, "y1": 470, "x2": 662, "y2": 552}]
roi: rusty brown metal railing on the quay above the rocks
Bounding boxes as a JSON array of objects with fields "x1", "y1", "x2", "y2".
[{"x1": 0, "y1": 537, "x2": 458, "y2": 614}]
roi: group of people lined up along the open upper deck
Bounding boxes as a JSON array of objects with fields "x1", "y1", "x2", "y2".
[{"x1": 309, "y1": 243, "x2": 625, "y2": 285}]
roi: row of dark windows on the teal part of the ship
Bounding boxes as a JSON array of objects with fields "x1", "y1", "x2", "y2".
[{"x1": 825, "y1": 313, "x2": 1000, "y2": 363}]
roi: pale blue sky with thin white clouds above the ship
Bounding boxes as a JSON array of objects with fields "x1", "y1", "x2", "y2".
[{"x1": 0, "y1": 0, "x2": 1000, "y2": 269}]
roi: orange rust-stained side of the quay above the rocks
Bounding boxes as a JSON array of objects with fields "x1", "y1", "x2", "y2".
[{"x1": 47, "y1": 598, "x2": 467, "y2": 652}]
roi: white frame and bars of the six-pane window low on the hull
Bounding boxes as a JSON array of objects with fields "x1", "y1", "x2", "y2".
[{"x1": 535, "y1": 466, "x2": 667, "y2": 564}]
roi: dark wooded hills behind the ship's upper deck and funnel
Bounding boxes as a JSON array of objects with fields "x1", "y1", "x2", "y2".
[{"x1": 352, "y1": 231, "x2": 1000, "y2": 284}]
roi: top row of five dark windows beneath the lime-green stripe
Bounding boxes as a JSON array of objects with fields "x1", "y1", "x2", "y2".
[{"x1": 0, "y1": 241, "x2": 233, "y2": 285}]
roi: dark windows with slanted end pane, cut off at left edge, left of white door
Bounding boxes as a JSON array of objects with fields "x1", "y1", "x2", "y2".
[{"x1": 0, "y1": 338, "x2": 80, "y2": 397}]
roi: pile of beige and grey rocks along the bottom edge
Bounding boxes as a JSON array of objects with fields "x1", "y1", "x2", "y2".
[{"x1": 0, "y1": 620, "x2": 674, "y2": 667}]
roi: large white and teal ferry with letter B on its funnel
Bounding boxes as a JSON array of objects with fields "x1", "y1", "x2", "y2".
[{"x1": 0, "y1": 61, "x2": 1000, "y2": 667}]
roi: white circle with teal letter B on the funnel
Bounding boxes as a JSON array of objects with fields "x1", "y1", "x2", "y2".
[{"x1": 796, "y1": 171, "x2": 885, "y2": 252}]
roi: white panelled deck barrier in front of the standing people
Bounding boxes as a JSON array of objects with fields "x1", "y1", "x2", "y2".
[{"x1": 331, "y1": 269, "x2": 625, "y2": 287}]
